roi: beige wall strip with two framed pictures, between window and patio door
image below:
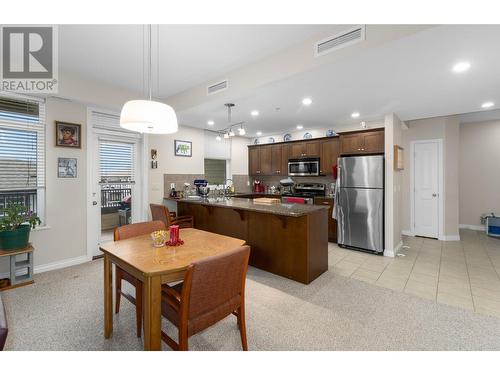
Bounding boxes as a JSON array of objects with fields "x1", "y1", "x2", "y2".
[{"x1": 0, "y1": 99, "x2": 87, "y2": 273}]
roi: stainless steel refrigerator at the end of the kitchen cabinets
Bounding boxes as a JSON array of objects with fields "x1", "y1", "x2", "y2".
[{"x1": 336, "y1": 155, "x2": 384, "y2": 253}]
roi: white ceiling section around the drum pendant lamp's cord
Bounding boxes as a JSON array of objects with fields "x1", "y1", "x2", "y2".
[{"x1": 59, "y1": 25, "x2": 331, "y2": 98}]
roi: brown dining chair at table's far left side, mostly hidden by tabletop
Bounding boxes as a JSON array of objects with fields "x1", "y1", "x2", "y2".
[{"x1": 114, "y1": 220, "x2": 167, "y2": 337}]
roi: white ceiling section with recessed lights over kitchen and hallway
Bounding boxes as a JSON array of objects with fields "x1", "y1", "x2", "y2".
[{"x1": 178, "y1": 25, "x2": 500, "y2": 136}]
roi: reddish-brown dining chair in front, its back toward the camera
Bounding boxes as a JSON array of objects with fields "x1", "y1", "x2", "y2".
[{"x1": 161, "y1": 246, "x2": 250, "y2": 350}]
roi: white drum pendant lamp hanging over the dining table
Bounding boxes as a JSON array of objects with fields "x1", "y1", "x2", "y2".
[{"x1": 120, "y1": 25, "x2": 178, "y2": 134}]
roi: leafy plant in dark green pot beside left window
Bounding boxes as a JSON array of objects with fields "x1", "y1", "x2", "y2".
[{"x1": 0, "y1": 204, "x2": 41, "y2": 250}]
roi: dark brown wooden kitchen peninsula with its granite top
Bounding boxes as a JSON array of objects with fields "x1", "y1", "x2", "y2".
[{"x1": 177, "y1": 198, "x2": 328, "y2": 284}]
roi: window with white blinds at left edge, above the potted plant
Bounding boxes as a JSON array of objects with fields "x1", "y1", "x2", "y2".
[{"x1": 0, "y1": 95, "x2": 45, "y2": 221}]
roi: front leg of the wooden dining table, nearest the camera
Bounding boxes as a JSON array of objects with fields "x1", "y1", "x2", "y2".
[{"x1": 143, "y1": 276, "x2": 161, "y2": 350}]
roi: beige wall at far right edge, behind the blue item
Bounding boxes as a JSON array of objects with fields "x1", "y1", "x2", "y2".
[{"x1": 459, "y1": 120, "x2": 500, "y2": 227}]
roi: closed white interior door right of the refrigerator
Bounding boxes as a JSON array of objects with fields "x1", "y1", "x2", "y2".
[{"x1": 410, "y1": 139, "x2": 443, "y2": 239}]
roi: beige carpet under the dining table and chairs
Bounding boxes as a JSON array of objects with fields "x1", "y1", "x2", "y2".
[{"x1": 2, "y1": 254, "x2": 500, "y2": 350}]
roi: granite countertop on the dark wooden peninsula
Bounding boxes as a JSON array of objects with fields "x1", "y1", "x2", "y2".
[{"x1": 171, "y1": 197, "x2": 328, "y2": 217}]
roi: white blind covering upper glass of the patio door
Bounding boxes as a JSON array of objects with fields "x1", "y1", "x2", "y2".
[{"x1": 99, "y1": 140, "x2": 135, "y2": 183}]
